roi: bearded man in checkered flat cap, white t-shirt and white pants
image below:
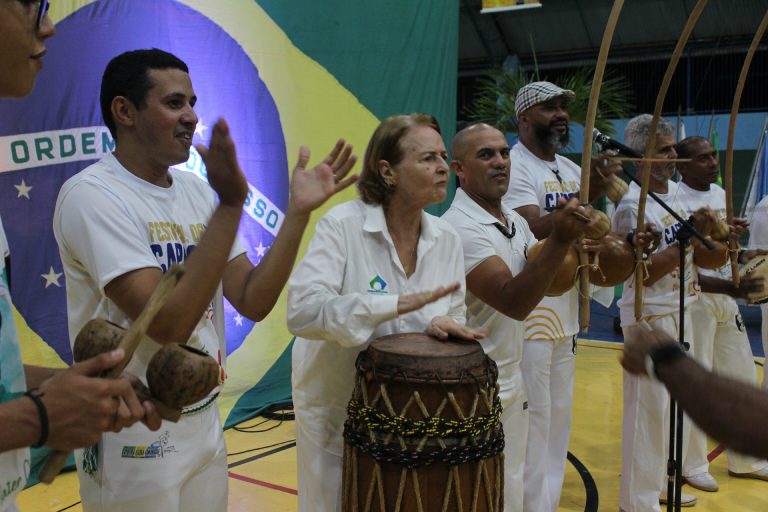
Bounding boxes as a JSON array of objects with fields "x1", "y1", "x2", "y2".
[{"x1": 503, "y1": 82, "x2": 612, "y2": 512}]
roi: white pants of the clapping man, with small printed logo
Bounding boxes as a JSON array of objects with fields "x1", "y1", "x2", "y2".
[{"x1": 75, "y1": 403, "x2": 228, "y2": 512}]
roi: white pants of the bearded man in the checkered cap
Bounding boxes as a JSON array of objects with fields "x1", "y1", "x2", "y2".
[{"x1": 518, "y1": 336, "x2": 576, "y2": 512}]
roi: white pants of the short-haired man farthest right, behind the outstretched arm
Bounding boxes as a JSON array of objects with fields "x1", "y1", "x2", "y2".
[{"x1": 683, "y1": 293, "x2": 768, "y2": 476}]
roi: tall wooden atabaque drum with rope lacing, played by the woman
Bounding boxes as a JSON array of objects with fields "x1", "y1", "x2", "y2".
[{"x1": 342, "y1": 333, "x2": 504, "y2": 512}]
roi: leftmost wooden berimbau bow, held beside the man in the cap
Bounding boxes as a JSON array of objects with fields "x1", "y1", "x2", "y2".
[{"x1": 579, "y1": 0, "x2": 624, "y2": 332}]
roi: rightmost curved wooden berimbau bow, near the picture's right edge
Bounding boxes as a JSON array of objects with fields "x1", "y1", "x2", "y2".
[{"x1": 728, "y1": 10, "x2": 768, "y2": 288}]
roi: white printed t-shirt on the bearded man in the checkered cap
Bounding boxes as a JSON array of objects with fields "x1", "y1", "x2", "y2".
[{"x1": 502, "y1": 142, "x2": 581, "y2": 340}]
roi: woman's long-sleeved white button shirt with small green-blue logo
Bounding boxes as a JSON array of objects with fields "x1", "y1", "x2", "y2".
[{"x1": 288, "y1": 200, "x2": 465, "y2": 456}]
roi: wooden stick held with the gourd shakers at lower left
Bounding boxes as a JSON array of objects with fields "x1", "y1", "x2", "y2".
[{"x1": 39, "y1": 265, "x2": 184, "y2": 484}]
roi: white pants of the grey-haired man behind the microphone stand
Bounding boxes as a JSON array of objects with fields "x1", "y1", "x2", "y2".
[{"x1": 620, "y1": 312, "x2": 693, "y2": 512}]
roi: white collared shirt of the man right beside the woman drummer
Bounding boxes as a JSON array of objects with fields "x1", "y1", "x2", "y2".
[{"x1": 442, "y1": 189, "x2": 536, "y2": 394}]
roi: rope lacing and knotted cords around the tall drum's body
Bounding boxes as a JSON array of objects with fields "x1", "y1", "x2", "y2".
[{"x1": 342, "y1": 353, "x2": 504, "y2": 512}]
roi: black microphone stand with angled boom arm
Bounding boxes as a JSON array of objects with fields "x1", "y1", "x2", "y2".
[{"x1": 595, "y1": 132, "x2": 715, "y2": 512}]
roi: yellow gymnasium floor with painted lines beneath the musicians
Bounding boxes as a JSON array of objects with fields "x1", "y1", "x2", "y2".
[{"x1": 19, "y1": 331, "x2": 768, "y2": 512}]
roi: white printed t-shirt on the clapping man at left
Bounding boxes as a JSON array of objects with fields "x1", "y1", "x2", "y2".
[{"x1": 53, "y1": 154, "x2": 244, "y2": 400}]
